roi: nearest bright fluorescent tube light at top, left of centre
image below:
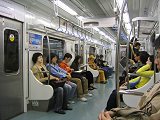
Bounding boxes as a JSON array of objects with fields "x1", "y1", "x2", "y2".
[{"x1": 57, "y1": 0, "x2": 78, "y2": 16}]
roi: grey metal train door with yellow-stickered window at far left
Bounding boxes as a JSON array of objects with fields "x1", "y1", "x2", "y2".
[{"x1": 0, "y1": 17, "x2": 23, "y2": 120}]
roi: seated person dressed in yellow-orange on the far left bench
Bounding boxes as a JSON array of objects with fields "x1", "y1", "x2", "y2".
[{"x1": 88, "y1": 55, "x2": 107, "y2": 83}]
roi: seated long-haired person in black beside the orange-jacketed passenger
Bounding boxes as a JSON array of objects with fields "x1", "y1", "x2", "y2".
[{"x1": 71, "y1": 55, "x2": 95, "y2": 90}]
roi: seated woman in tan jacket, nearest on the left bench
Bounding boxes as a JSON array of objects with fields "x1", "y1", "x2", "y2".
[{"x1": 32, "y1": 53, "x2": 68, "y2": 114}]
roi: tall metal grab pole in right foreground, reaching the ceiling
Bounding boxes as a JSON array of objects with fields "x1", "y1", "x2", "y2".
[{"x1": 115, "y1": 0, "x2": 127, "y2": 107}]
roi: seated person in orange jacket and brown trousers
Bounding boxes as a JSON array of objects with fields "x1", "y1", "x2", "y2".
[{"x1": 59, "y1": 53, "x2": 88, "y2": 102}]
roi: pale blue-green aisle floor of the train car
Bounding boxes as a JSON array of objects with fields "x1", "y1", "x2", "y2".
[{"x1": 12, "y1": 74, "x2": 115, "y2": 120}]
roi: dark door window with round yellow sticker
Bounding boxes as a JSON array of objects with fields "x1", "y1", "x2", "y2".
[{"x1": 4, "y1": 29, "x2": 19, "y2": 73}]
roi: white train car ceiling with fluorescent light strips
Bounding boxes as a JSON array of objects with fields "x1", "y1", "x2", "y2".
[{"x1": 13, "y1": 0, "x2": 158, "y2": 44}]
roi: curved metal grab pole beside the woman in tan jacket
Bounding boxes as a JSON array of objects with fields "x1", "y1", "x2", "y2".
[{"x1": 46, "y1": 30, "x2": 51, "y2": 85}]
